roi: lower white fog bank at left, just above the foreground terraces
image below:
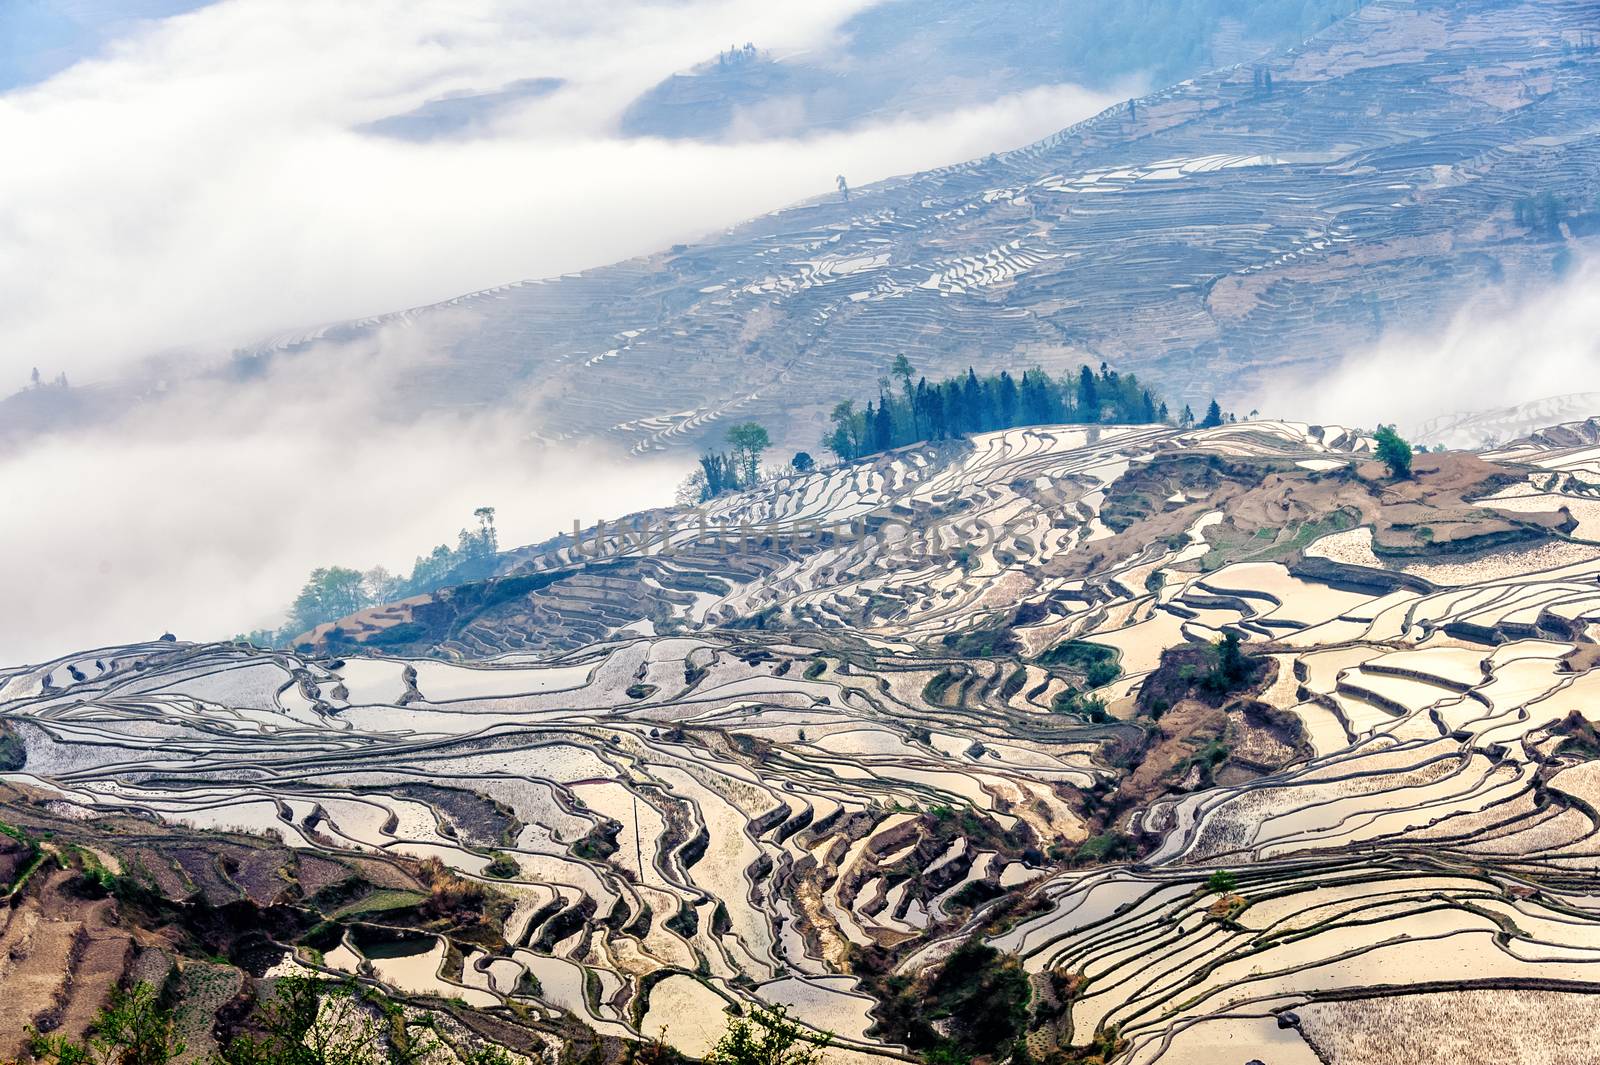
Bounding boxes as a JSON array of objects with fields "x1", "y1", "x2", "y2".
[{"x1": 0, "y1": 321, "x2": 690, "y2": 664}]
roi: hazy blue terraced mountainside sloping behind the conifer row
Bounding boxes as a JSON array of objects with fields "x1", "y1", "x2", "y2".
[{"x1": 236, "y1": 0, "x2": 1600, "y2": 451}]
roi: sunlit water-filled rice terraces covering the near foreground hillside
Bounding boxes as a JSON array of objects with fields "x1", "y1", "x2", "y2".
[{"x1": 15, "y1": 422, "x2": 1600, "y2": 1063}]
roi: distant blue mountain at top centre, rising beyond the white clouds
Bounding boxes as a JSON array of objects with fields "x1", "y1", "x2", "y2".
[{"x1": 622, "y1": 0, "x2": 1357, "y2": 138}]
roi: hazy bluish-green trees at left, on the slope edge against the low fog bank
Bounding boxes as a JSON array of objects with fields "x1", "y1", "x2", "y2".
[{"x1": 238, "y1": 507, "x2": 499, "y2": 648}]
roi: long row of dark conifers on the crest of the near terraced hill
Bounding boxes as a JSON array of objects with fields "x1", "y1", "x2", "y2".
[{"x1": 822, "y1": 355, "x2": 1177, "y2": 462}]
